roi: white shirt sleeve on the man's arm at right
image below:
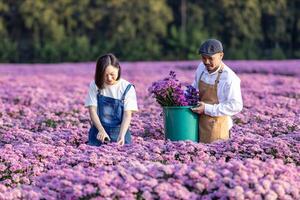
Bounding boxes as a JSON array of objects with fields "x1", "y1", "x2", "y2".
[{"x1": 204, "y1": 78, "x2": 243, "y2": 116}]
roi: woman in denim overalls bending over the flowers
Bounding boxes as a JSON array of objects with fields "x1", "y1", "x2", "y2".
[{"x1": 85, "y1": 54, "x2": 138, "y2": 146}]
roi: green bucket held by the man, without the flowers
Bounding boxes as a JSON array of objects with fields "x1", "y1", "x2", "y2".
[{"x1": 163, "y1": 106, "x2": 199, "y2": 142}]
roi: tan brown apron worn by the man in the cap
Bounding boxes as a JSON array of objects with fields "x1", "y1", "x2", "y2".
[{"x1": 198, "y1": 67, "x2": 229, "y2": 143}]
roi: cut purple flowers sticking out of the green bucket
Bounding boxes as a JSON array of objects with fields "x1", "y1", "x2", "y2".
[{"x1": 148, "y1": 71, "x2": 199, "y2": 107}]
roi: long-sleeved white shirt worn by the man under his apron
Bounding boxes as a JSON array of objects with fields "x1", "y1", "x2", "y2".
[{"x1": 192, "y1": 62, "x2": 243, "y2": 128}]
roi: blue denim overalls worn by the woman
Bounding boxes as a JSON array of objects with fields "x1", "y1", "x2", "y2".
[{"x1": 88, "y1": 84, "x2": 131, "y2": 146}]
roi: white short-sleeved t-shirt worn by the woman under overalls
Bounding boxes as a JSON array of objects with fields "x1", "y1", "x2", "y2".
[{"x1": 85, "y1": 78, "x2": 138, "y2": 111}]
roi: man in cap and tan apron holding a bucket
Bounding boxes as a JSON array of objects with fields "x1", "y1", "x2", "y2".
[{"x1": 192, "y1": 39, "x2": 243, "y2": 143}]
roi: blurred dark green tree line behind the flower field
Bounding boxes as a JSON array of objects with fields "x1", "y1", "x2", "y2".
[{"x1": 0, "y1": 0, "x2": 300, "y2": 62}]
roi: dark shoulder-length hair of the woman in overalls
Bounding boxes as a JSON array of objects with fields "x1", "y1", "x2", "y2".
[{"x1": 95, "y1": 53, "x2": 121, "y2": 89}]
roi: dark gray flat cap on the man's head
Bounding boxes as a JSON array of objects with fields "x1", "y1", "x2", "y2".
[{"x1": 199, "y1": 39, "x2": 223, "y2": 56}]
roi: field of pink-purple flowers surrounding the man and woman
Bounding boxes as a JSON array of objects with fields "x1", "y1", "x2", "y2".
[{"x1": 0, "y1": 60, "x2": 300, "y2": 200}]
